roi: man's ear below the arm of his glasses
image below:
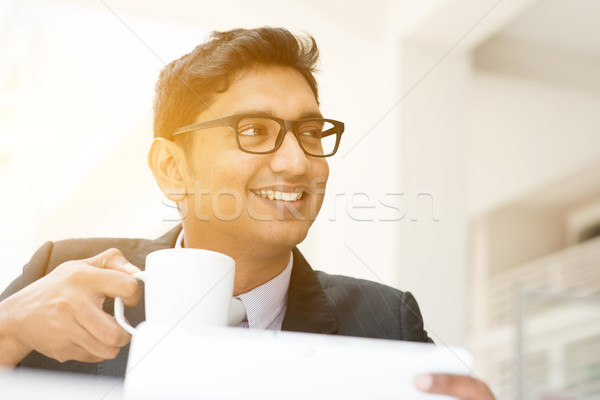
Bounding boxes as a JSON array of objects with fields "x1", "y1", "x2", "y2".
[{"x1": 148, "y1": 137, "x2": 186, "y2": 202}]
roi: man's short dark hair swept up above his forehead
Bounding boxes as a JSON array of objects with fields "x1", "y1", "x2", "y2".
[{"x1": 154, "y1": 27, "x2": 319, "y2": 138}]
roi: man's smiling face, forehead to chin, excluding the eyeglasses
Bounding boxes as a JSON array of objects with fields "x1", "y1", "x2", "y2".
[{"x1": 178, "y1": 66, "x2": 329, "y2": 250}]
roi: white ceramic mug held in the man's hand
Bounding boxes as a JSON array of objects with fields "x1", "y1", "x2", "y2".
[{"x1": 115, "y1": 248, "x2": 244, "y2": 334}]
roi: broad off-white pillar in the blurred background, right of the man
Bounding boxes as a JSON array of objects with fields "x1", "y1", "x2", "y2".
[{"x1": 397, "y1": 42, "x2": 471, "y2": 345}]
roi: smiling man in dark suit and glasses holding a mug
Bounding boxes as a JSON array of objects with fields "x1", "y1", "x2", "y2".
[{"x1": 0, "y1": 28, "x2": 491, "y2": 398}]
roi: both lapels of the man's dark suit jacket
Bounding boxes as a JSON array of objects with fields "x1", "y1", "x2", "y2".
[{"x1": 131, "y1": 225, "x2": 338, "y2": 333}]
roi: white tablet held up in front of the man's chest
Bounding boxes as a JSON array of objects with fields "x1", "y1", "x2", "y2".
[{"x1": 125, "y1": 323, "x2": 472, "y2": 400}]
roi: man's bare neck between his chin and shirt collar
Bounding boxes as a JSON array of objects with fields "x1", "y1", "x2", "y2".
[{"x1": 183, "y1": 227, "x2": 292, "y2": 296}]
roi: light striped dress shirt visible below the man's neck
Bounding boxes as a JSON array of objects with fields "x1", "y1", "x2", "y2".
[{"x1": 175, "y1": 229, "x2": 294, "y2": 330}]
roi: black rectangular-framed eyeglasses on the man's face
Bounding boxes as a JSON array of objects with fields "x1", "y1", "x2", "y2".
[{"x1": 174, "y1": 114, "x2": 344, "y2": 157}]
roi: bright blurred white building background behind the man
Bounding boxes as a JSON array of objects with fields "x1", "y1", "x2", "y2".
[{"x1": 0, "y1": 0, "x2": 600, "y2": 399}]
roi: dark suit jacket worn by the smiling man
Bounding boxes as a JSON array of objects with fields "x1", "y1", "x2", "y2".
[{"x1": 0, "y1": 226, "x2": 431, "y2": 376}]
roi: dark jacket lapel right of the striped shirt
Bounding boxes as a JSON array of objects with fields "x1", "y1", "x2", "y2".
[{"x1": 281, "y1": 247, "x2": 338, "y2": 333}]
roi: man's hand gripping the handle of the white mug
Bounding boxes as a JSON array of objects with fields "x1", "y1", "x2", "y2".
[{"x1": 0, "y1": 249, "x2": 140, "y2": 365}]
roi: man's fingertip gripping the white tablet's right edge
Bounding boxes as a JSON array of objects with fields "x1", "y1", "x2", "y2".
[{"x1": 415, "y1": 374, "x2": 494, "y2": 400}]
